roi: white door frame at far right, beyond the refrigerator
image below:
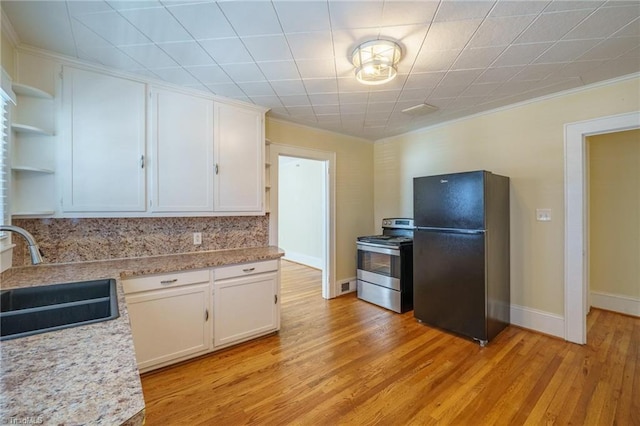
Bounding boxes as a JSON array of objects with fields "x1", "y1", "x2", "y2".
[{"x1": 564, "y1": 111, "x2": 640, "y2": 344}]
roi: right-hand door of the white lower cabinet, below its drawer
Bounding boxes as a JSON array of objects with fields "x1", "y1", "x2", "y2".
[{"x1": 213, "y1": 272, "x2": 279, "y2": 346}]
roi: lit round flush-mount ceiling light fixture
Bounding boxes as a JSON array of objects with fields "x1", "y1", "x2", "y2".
[{"x1": 351, "y1": 40, "x2": 402, "y2": 85}]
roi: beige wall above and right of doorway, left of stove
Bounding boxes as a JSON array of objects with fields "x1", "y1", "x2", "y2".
[{"x1": 266, "y1": 118, "x2": 379, "y2": 282}]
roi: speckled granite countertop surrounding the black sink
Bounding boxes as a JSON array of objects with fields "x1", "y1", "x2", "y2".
[{"x1": 0, "y1": 246, "x2": 284, "y2": 425}]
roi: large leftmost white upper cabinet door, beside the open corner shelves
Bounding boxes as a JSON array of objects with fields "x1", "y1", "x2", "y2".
[{"x1": 61, "y1": 67, "x2": 146, "y2": 212}]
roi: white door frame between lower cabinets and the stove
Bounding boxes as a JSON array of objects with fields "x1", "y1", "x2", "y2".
[{"x1": 269, "y1": 142, "x2": 338, "y2": 299}]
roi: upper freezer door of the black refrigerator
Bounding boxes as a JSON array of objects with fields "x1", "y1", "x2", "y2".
[{"x1": 413, "y1": 171, "x2": 487, "y2": 229}]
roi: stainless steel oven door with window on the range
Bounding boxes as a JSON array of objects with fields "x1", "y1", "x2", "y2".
[{"x1": 357, "y1": 243, "x2": 401, "y2": 291}]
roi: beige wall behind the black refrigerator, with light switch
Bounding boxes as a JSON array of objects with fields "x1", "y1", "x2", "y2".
[{"x1": 374, "y1": 78, "x2": 640, "y2": 315}]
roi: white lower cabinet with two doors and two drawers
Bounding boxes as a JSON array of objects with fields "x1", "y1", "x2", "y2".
[{"x1": 123, "y1": 260, "x2": 280, "y2": 372}]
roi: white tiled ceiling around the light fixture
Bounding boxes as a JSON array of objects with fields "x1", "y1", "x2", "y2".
[{"x1": 0, "y1": 0, "x2": 640, "y2": 140}]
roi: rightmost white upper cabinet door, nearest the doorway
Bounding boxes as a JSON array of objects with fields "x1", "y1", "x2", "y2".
[{"x1": 214, "y1": 102, "x2": 264, "y2": 213}]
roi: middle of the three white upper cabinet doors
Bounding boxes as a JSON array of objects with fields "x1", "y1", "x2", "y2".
[{"x1": 150, "y1": 89, "x2": 213, "y2": 213}]
